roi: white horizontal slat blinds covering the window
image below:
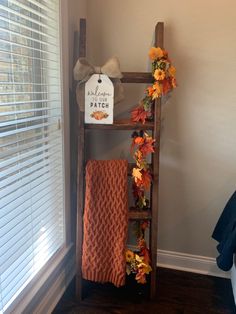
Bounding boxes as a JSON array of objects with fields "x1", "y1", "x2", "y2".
[{"x1": 0, "y1": 0, "x2": 65, "y2": 313}]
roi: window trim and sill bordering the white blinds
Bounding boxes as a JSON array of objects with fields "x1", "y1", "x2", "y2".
[{"x1": 0, "y1": 0, "x2": 75, "y2": 314}]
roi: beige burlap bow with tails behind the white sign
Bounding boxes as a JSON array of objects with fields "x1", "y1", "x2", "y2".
[{"x1": 73, "y1": 57, "x2": 124, "y2": 111}]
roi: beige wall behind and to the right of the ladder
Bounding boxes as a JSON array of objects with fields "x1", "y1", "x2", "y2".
[{"x1": 87, "y1": 0, "x2": 236, "y2": 257}]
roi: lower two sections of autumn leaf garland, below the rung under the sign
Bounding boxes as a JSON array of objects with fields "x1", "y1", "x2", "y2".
[{"x1": 126, "y1": 130, "x2": 155, "y2": 284}]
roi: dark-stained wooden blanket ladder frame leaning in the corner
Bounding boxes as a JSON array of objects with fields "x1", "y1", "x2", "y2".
[{"x1": 72, "y1": 19, "x2": 164, "y2": 301}]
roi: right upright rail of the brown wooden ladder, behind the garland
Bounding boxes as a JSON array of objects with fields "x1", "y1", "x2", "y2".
[{"x1": 150, "y1": 22, "x2": 164, "y2": 299}]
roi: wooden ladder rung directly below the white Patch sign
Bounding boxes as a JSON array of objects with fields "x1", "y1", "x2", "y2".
[{"x1": 85, "y1": 119, "x2": 154, "y2": 130}]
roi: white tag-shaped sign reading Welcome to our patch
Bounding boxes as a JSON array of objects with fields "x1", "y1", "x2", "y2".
[{"x1": 85, "y1": 74, "x2": 114, "y2": 124}]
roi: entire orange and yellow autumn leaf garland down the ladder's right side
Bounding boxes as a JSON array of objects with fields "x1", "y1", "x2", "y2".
[{"x1": 126, "y1": 47, "x2": 176, "y2": 284}]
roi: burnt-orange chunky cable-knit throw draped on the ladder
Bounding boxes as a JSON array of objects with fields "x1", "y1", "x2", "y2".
[{"x1": 82, "y1": 160, "x2": 128, "y2": 287}]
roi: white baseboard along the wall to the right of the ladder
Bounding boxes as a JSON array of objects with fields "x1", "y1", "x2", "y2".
[{"x1": 128, "y1": 245, "x2": 230, "y2": 278}]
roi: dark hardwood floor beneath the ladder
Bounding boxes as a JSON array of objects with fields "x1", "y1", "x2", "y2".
[{"x1": 53, "y1": 268, "x2": 236, "y2": 314}]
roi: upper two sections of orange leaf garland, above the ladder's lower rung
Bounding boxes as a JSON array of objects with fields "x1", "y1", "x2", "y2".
[{"x1": 131, "y1": 47, "x2": 176, "y2": 209}]
